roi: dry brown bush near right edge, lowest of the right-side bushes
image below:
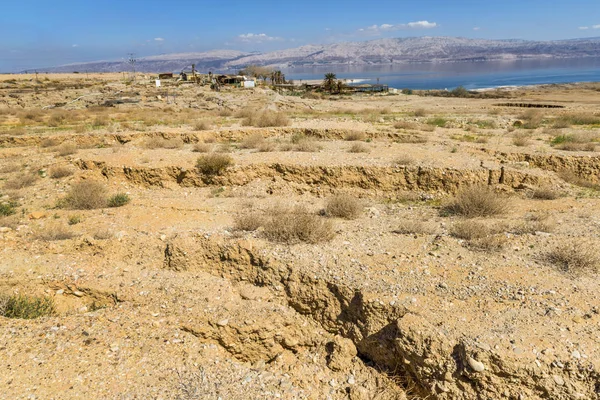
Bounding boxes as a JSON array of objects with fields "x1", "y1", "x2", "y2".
[{"x1": 545, "y1": 241, "x2": 600, "y2": 275}]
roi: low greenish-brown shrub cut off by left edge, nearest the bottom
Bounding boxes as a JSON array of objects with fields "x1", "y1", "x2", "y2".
[{"x1": 0, "y1": 294, "x2": 56, "y2": 319}]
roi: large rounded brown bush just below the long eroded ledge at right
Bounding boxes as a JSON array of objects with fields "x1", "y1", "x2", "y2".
[{"x1": 444, "y1": 185, "x2": 508, "y2": 218}]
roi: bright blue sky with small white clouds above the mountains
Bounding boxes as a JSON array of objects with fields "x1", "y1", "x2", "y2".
[{"x1": 0, "y1": 0, "x2": 600, "y2": 71}]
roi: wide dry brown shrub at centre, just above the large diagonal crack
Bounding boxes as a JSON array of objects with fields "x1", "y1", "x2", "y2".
[{"x1": 264, "y1": 206, "x2": 334, "y2": 244}]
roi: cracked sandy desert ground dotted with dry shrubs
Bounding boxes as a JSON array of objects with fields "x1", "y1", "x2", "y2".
[{"x1": 0, "y1": 74, "x2": 600, "y2": 400}]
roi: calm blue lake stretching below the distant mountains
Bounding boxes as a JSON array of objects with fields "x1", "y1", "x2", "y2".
[{"x1": 283, "y1": 57, "x2": 600, "y2": 89}]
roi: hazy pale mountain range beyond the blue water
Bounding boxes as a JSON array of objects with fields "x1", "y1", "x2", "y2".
[{"x1": 38, "y1": 37, "x2": 600, "y2": 72}]
